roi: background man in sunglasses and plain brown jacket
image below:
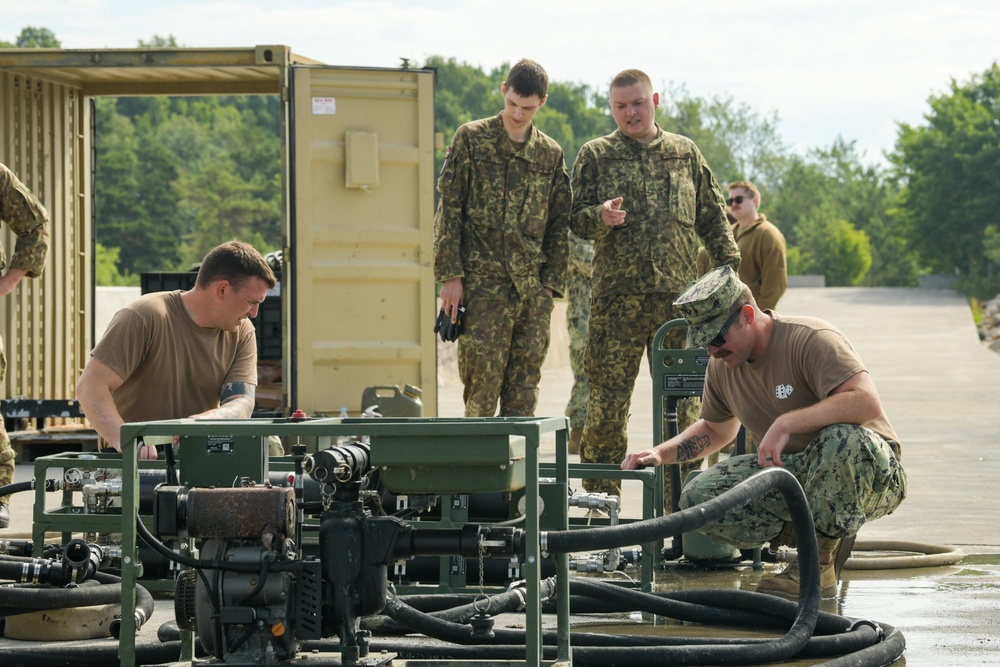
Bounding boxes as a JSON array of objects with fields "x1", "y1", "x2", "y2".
[{"x1": 698, "y1": 181, "x2": 788, "y2": 310}]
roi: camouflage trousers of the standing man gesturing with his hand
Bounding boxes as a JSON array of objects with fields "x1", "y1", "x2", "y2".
[{"x1": 580, "y1": 294, "x2": 701, "y2": 496}]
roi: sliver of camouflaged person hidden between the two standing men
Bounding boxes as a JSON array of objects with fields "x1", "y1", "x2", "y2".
[{"x1": 566, "y1": 232, "x2": 594, "y2": 454}]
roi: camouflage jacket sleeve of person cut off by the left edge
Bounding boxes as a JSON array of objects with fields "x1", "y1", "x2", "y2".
[{"x1": 0, "y1": 164, "x2": 49, "y2": 278}]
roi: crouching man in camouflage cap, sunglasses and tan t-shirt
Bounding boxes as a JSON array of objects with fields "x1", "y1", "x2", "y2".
[{"x1": 621, "y1": 266, "x2": 906, "y2": 597}]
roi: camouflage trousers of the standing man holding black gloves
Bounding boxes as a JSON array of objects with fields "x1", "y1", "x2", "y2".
[{"x1": 458, "y1": 289, "x2": 553, "y2": 417}]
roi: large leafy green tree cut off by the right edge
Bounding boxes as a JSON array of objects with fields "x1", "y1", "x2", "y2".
[{"x1": 891, "y1": 63, "x2": 1000, "y2": 298}]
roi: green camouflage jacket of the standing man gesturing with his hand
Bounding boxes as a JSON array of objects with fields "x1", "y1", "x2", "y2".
[{"x1": 572, "y1": 130, "x2": 740, "y2": 296}]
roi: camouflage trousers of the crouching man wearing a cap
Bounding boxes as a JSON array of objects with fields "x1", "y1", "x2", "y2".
[{"x1": 680, "y1": 424, "x2": 906, "y2": 549}]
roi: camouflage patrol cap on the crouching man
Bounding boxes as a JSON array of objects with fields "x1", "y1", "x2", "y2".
[{"x1": 674, "y1": 265, "x2": 743, "y2": 348}]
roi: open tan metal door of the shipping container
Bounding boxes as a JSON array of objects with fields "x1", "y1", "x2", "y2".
[{"x1": 286, "y1": 67, "x2": 437, "y2": 416}]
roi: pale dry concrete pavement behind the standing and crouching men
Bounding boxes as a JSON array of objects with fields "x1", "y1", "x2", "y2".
[{"x1": 438, "y1": 288, "x2": 1000, "y2": 553}]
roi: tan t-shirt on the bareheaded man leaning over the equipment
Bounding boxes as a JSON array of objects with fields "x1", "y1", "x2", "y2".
[{"x1": 91, "y1": 290, "x2": 257, "y2": 422}]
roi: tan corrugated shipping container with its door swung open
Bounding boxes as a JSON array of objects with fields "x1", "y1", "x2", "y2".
[{"x1": 0, "y1": 46, "x2": 437, "y2": 438}]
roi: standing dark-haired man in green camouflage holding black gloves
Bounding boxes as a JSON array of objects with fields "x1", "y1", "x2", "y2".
[{"x1": 434, "y1": 59, "x2": 572, "y2": 417}]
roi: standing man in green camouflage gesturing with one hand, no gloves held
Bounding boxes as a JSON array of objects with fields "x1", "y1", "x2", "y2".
[{"x1": 571, "y1": 70, "x2": 739, "y2": 494}]
